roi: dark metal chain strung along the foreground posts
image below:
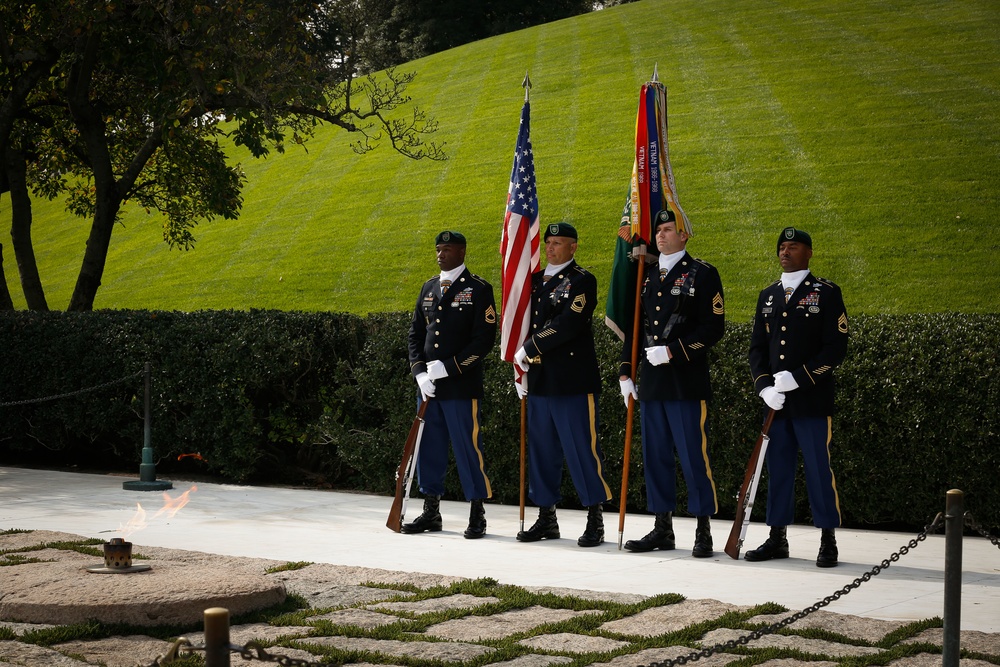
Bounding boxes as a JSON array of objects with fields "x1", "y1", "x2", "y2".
[{"x1": 139, "y1": 512, "x2": 960, "y2": 667}]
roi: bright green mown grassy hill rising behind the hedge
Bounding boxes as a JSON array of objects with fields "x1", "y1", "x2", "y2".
[{"x1": 0, "y1": 0, "x2": 1000, "y2": 320}]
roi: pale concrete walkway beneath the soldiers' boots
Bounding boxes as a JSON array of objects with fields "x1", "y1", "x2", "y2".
[{"x1": 0, "y1": 468, "x2": 1000, "y2": 633}]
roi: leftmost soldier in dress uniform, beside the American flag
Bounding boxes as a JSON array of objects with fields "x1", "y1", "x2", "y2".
[{"x1": 402, "y1": 231, "x2": 497, "y2": 539}]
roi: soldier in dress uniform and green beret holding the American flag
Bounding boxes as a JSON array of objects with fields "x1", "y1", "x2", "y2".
[{"x1": 514, "y1": 222, "x2": 611, "y2": 547}]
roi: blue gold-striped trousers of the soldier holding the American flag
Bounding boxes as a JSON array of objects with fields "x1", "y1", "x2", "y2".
[{"x1": 528, "y1": 394, "x2": 611, "y2": 507}]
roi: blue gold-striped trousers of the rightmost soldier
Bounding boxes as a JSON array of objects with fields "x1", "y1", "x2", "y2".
[{"x1": 767, "y1": 417, "x2": 840, "y2": 528}]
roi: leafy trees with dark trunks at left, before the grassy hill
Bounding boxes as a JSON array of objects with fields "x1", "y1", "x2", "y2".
[{"x1": 0, "y1": 0, "x2": 445, "y2": 310}]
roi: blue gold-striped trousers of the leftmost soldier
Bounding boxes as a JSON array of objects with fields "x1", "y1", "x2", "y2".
[{"x1": 417, "y1": 398, "x2": 493, "y2": 500}]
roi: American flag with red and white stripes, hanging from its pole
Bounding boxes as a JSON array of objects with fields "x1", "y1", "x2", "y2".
[{"x1": 500, "y1": 100, "x2": 539, "y2": 368}]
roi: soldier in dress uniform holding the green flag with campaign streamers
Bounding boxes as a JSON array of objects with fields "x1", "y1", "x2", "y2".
[{"x1": 619, "y1": 211, "x2": 726, "y2": 558}]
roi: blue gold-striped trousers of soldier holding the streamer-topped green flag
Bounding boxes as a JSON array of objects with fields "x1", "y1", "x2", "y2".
[{"x1": 639, "y1": 401, "x2": 719, "y2": 516}]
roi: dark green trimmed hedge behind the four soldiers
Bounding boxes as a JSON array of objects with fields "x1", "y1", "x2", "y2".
[{"x1": 0, "y1": 311, "x2": 1000, "y2": 527}]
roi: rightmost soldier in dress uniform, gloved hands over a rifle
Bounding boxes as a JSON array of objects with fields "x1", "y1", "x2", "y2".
[{"x1": 744, "y1": 227, "x2": 848, "y2": 567}]
